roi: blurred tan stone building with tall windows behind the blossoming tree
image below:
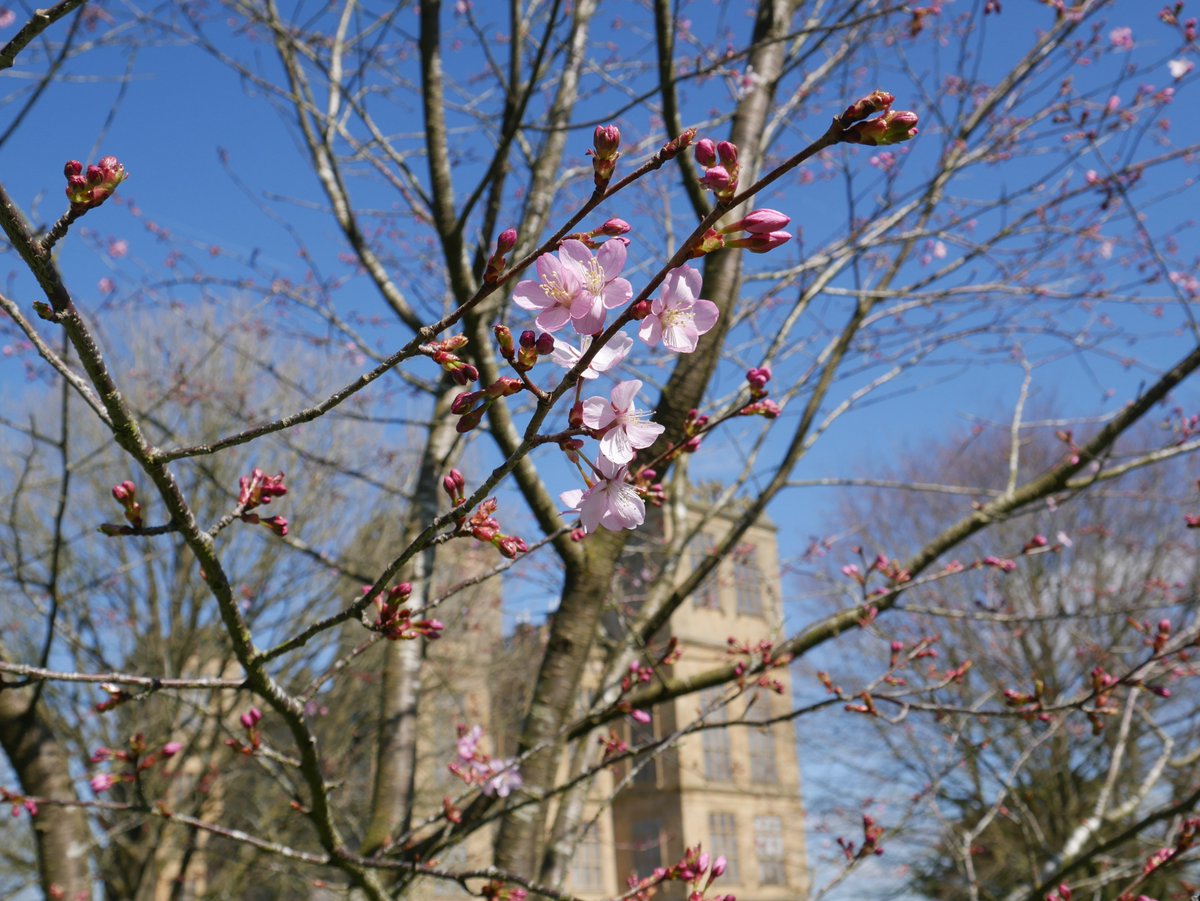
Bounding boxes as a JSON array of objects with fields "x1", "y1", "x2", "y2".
[{"x1": 410, "y1": 515, "x2": 809, "y2": 901}]
